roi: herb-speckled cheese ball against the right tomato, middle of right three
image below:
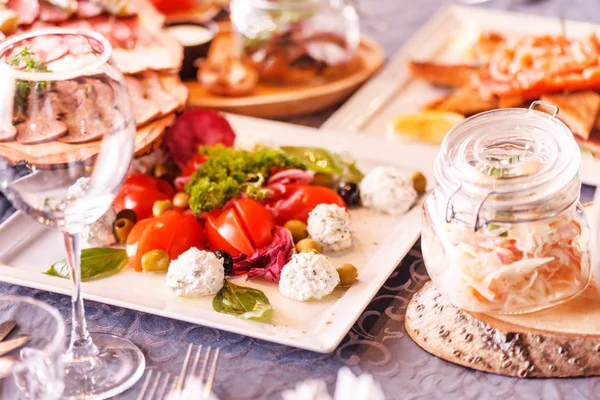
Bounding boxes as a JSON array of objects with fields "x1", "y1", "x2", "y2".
[{"x1": 306, "y1": 204, "x2": 352, "y2": 251}]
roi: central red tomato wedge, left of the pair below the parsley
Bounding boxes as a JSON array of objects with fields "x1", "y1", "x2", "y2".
[{"x1": 206, "y1": 208, "x2": 254, "y2": 257}]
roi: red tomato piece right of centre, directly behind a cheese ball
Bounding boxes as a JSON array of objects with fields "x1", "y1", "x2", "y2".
[{"x1": 275, "y1": 184, "x2": 346, "y2": 226}]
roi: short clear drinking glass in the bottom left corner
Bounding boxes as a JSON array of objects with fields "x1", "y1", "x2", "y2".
[{"x1": 0, "y1": 296, "x2": 65, "y2": 400}]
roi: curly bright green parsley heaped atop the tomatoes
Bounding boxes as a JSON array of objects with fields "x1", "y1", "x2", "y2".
[{"x1": 185, "y1": 145, "x2": 305, "y2": 214}]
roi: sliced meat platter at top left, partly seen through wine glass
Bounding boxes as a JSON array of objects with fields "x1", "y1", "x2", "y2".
[{"x1": 0, "y1": 0, "x2": 188, "y2": 168}]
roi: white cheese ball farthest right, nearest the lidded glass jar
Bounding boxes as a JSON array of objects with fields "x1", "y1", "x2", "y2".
[{"x1": 360, "y1": 167, "x2": 417, "y2": 215}]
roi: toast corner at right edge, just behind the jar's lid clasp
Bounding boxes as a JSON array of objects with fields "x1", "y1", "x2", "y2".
[{"x1": 541, "y1": 90, "x2": 600, "y2": 139}]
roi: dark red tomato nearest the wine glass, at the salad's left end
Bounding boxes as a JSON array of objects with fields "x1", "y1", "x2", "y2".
[{"x1": 113, "y1": 174, "x2": 175, "y2": 220}]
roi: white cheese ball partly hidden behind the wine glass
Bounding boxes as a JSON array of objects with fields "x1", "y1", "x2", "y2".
[{"x1": 67, "y1": 177, "x2": 117, "y2": 247}]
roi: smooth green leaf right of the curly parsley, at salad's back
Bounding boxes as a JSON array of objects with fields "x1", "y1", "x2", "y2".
[{"x1": 281, "y1": 146, "x2": 364, "y2": 183}]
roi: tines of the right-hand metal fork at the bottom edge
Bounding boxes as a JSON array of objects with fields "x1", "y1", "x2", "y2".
[{"x1": 174, "y1": 344, "x2": 221, "y2": 399}]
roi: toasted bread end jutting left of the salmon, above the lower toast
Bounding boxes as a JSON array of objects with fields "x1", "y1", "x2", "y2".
[{"x1": 408, "y1": 61, "x2": 478, "y2": 88}]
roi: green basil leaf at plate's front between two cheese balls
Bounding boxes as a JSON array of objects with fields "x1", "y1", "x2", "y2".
[{"x1": 213, "y1": 280, "x2": 273, "y2": 322}]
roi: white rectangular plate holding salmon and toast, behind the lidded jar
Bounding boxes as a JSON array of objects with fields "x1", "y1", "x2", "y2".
[{"x1": 322, "y1": 6, "x2": 600, "y2": 185}]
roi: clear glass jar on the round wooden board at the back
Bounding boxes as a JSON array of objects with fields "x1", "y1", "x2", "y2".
[{"x1": 230, "y1": 0, "x2": 360, "y2": 84}]
